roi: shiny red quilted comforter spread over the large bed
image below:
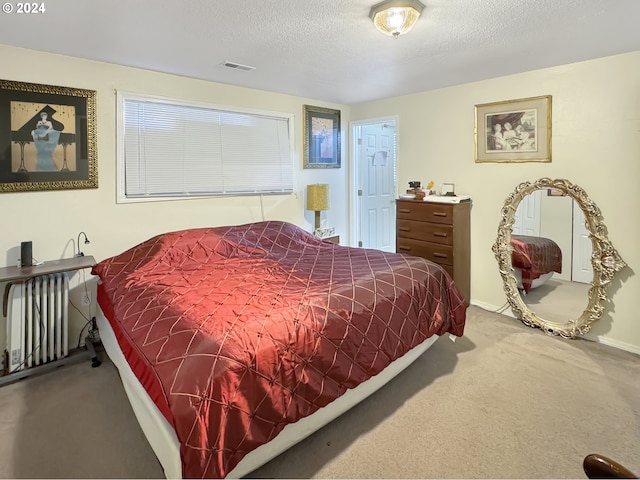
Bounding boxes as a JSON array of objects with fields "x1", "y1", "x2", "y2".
[{"x1": 93, "y1": 222, "x2": 466, "y2": 478}]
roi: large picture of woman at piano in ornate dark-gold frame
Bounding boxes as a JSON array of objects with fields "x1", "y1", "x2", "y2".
[{"x1": 0, "y1": 80, "x2": 98, "y2": 192}]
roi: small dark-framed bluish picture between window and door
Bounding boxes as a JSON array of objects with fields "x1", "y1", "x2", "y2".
[{"x1": 303, "y1": 105, "x2": 340, "y2": 168}]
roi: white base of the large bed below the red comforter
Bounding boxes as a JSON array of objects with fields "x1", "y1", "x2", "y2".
[{"x1": 96, "y1": 309, "x2": 439, "y2": 478}]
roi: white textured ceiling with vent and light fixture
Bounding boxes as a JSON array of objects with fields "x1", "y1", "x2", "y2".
[{"x1": 0, "y1": 0, "x2": 640, "y2": 104}]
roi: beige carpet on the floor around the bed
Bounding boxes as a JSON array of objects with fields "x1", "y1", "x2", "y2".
[{"x1": 0, "y1": 307, "x2": 640, "y2": 478}]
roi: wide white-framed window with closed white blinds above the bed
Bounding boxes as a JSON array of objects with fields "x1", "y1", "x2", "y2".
[{"x1": 118, "y1": 92, "x2": 293, "y2": 202}]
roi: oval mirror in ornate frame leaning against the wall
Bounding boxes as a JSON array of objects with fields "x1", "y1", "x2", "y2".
[{"x1": 492, "y1": 178, "x2": 626, "y2": 338}]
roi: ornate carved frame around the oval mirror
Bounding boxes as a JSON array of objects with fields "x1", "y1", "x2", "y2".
[{"x1": 492, "y1": 178, "x2": 626, "y2": 338}]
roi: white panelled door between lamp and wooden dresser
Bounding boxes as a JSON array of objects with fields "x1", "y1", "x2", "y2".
[{"x1": 352, "y1": 118, "x2": 397, "y2": 252}]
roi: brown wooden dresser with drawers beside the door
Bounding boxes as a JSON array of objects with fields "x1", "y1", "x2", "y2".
[{"x1": 396, "y1": 200, "x2": 471, "y2": 304}]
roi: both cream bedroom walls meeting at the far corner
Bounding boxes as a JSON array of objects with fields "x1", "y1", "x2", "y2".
[{"x1": 0, "y1": 45, "x2": 640, "y2": 360}]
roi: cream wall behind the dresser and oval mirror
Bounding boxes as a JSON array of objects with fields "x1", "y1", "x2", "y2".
[{"x1": 351, "y1": 52, "x2": 640, "y2": 353}]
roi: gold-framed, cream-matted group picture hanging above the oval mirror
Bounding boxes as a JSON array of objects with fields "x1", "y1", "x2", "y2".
[{"x1": 475, "y1": 95, "x2": 551, "y2": 163}]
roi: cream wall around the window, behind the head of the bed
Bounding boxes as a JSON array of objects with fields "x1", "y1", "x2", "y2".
[{"x1": 0, "y1": 45, "x2": 349, "y2": 352}]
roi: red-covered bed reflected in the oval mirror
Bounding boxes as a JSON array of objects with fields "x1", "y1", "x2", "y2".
[{"x1": 511, "y1": 235, "x2": 562, "y2": 294}]
